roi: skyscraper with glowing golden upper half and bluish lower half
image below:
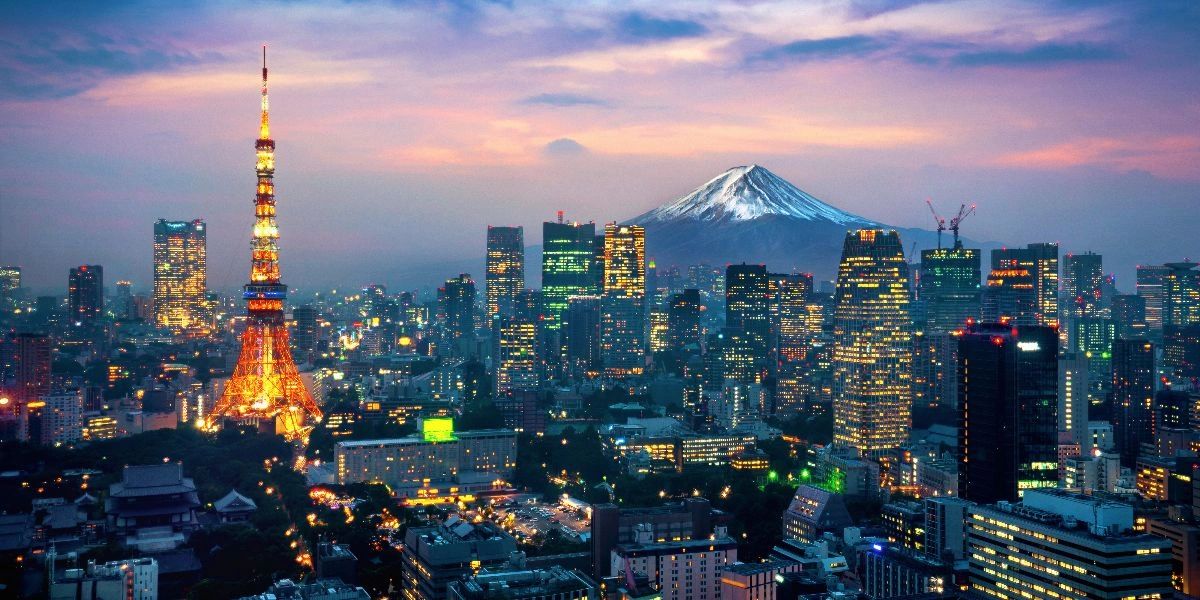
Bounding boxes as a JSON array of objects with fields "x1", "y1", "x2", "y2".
[{"x1": 600, "y1": 223, "x2": 646, "y2": 377}]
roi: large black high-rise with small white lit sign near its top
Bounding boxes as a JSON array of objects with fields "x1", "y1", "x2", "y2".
[{"x1": 959, "y1": 324, "x2": 1058, "y2": 504}]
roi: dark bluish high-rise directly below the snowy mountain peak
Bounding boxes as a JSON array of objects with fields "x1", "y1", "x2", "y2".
[{"x1": 725, "y1": 263, "x2": 772, "y2": 380}]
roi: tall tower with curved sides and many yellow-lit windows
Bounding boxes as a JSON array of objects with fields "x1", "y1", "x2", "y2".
[{"x1": 833, "y1": 229, "x2": 912, "y2": 452}]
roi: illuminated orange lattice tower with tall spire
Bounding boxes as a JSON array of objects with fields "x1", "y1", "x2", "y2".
[{"x1": 212, "y1": 46, "x2": 322, "y2": 440}]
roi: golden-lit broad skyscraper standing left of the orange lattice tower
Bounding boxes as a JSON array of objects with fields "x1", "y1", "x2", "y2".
[{"x1": 154, "y1": 218, "x2": 209, "y2": 330}]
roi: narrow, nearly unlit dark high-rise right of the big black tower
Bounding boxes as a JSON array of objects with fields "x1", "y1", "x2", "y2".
[{"x1": 1112, "y1": 340, "x2": 1156, "y2": 467}]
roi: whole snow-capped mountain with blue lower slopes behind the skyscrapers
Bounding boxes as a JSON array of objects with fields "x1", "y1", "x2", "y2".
[{"x1": 626, "y1": 164, "x2": 955, "y2": 278}]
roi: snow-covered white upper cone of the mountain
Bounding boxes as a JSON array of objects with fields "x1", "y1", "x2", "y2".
[{"x1": 631, "y1": 164, "x2": 876, "y2": 227}]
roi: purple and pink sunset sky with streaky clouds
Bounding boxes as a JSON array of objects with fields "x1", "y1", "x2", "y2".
[{"x1": 0, "y1": 0, "x2": 1200, "y2": 294}]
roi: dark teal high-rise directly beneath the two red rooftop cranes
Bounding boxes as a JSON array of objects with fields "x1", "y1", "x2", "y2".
[{"x1": 919, "y1": 242, "x2": 982, "y2": 332}]
